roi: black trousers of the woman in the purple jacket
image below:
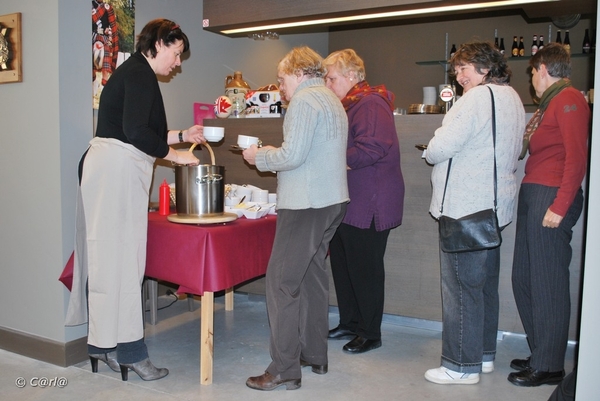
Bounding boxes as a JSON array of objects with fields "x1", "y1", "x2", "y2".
[{"x1": 329, "y1": 222, "x2": 390, "y2": 340}]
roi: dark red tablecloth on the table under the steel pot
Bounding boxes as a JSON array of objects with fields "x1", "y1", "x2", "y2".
[{"x1": 59, "y1": 212, "x2": 277, "y2": 295}]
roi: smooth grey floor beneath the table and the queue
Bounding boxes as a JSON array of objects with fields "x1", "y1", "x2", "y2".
[{"x1": 0, "y1": 294, "x2": 573, "y2": 401}]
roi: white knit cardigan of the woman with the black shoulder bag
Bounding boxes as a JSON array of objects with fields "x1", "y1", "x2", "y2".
[{"x1": 426, "y1": 85, "x2": 525, "y2": 226}]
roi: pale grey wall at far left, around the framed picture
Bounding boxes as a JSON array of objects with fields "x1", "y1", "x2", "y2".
[{"x1": 0, "y1": 0, "x2": 92, "y2": 342}]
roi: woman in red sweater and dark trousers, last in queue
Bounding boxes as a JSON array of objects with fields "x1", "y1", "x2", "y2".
[{"x1": 508, "y1": 43, "x2": 590, "y2": 387}]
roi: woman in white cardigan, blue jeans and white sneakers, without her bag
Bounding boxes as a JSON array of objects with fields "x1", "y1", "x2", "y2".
[{"x1": 425, "y1": 42, "x2": 525, "y2": 384}]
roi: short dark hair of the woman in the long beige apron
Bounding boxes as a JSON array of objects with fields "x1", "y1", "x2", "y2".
[{"x1": 135, "y1": 18, "x2": 190, "y2": 58}]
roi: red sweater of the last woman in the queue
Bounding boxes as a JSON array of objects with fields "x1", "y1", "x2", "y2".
[{"x1": 523, "y1": 87, "x2": 590, "y2": 217}]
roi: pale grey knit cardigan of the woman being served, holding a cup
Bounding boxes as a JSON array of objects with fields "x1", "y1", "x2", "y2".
[{"x1": 256, "y1": 78, "x2": 349, "y2": 210}]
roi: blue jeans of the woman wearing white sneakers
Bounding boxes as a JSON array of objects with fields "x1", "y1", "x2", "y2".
[{"x1": 440, "y1": 241, "x2": 500, "y2": 373}]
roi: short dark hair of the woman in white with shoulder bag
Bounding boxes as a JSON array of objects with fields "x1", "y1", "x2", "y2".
[{"x1": 450, "y1": 42, "x2": 512, "y2": 84}]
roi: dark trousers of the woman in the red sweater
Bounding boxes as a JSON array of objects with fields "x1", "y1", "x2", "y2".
[{"x1": 512, "y1": 184, "x2": 583, "y2": 372}]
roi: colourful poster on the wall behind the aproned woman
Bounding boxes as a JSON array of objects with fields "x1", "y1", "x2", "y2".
[{"x1": 92, "y1": 0, "x2": 135, "y2": 109}]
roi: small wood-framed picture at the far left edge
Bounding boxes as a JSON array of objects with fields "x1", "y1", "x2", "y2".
[{"x1": 0, "y1": 13, "x2": 23, "y2": 84}]
